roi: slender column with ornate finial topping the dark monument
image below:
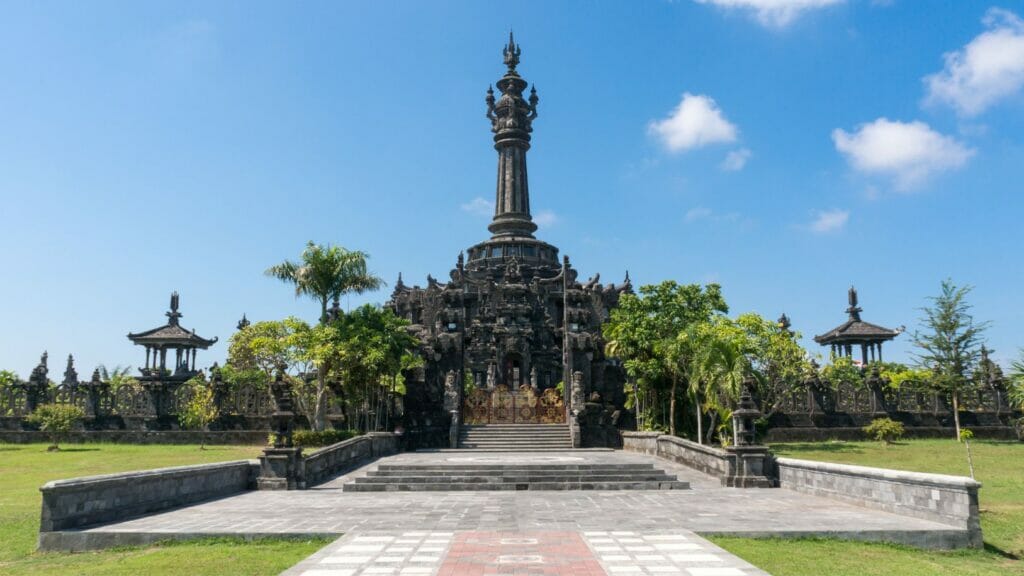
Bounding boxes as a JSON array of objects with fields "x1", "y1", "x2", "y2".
[{"x1": 486, "y1": 32, "x2": 539, "y2": 238}]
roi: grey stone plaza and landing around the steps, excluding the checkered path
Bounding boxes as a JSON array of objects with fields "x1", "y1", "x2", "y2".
[{"x1": 79, "y1": 451, "x2": 950, "y2": 534}]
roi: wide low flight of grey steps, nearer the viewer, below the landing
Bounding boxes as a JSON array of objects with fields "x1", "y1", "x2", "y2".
[{"x1": 342, "y1": 460, "x2": 690, "y2": 492}]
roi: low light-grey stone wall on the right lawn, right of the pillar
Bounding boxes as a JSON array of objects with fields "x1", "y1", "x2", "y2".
[{"x1": 775, "y1": 458, "x2": 982, "y2": 547}]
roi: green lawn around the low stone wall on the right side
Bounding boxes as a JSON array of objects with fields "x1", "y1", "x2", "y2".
[{"x1": 712, "y1": 440, "x2": 1024, "y2": 576}]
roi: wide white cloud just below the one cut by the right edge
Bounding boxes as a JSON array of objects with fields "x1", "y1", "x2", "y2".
[{"x1": 831, "y1": 118, "x2": 974, "y2": 191}]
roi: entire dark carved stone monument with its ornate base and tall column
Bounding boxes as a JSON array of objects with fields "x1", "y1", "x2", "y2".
[{"x1": 388, "y1": 34, "x2": 631, "y2": 438}]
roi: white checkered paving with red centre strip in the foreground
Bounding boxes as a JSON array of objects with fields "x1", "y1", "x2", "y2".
[{"x1": 285, "y1": 530, "x2": 767, "y2": 576}]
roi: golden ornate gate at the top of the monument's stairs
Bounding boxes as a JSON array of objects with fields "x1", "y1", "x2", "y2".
[{"x1": 463, "y1": 384, "x2": 565, "y2": 424}]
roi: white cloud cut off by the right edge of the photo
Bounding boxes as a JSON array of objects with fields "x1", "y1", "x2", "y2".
[{"x1": 924, "y1": 8, "x2": 1024, "y2": 116}]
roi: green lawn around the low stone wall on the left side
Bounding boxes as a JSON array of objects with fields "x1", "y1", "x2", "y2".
[{"x1": 0, "y1": 444, "x2": 327, "y2": 576}]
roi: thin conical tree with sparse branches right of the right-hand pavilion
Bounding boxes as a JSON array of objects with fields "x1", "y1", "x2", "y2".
[{"x1": 913, "y1": 280, "x2": 988, "y2": 441}]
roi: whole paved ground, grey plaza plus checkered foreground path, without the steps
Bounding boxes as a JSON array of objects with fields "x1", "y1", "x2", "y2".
[{"x1": 70, "y1": 451, "x2": 953, "y2": 576}]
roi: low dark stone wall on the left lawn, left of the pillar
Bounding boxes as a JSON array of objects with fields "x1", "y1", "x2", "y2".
[{"x1": 39, "y1": 460, "x2": 258, "y2": 532}]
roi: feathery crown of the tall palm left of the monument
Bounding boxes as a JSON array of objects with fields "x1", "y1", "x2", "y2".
[{"x1": 266, "y1": 241, "x2": 384, "y2": 323}]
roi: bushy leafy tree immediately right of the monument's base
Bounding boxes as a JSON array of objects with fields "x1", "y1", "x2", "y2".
[{"x1": 603, "y1": 280, "x2": 728, "y2": 436}]
